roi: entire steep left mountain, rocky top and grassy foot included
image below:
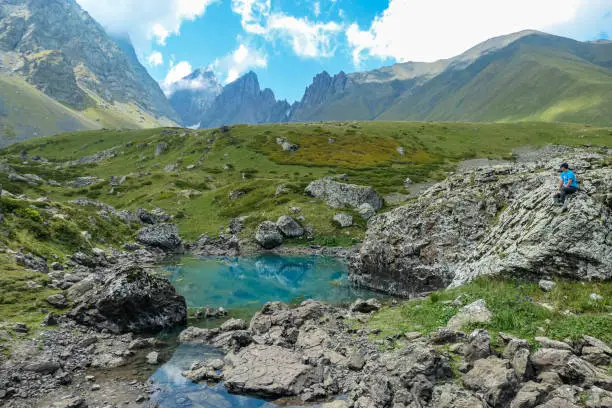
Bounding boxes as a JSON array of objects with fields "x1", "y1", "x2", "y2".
[{"x1": 0, "y1": 0, "x2": 180, "y2": 145}]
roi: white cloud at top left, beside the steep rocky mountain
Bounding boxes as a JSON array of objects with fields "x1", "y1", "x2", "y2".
[{"x1": 77, "y1": 0, "x2": 217, "y2": 52}]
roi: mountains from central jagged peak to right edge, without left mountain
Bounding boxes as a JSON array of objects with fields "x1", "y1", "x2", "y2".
[{"x1": 175, "y1": 31, "x2": 612, "y2": 127}]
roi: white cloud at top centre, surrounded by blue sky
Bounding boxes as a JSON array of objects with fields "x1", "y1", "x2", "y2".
[{"x1": 232, "y1": 0, "x2": 342, "y2": 58}]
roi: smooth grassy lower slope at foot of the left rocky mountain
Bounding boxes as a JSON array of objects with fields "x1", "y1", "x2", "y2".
[{"x1": 0, "y1": 75, "x2": 100, "y2": 147}]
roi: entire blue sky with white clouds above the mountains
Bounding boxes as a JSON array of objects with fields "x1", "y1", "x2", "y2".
[{"x1": 77, "y1": 0, "x2": 612, "y2": 102}]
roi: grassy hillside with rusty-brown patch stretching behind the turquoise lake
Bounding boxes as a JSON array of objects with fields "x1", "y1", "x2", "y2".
[{"x1": 0, "y1": 122, "x2": 612, "y2": 244}]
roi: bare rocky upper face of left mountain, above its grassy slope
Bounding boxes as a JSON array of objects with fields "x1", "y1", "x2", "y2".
[{"x1": 0, "y1": 0, "x2": 178, "y2": 120}]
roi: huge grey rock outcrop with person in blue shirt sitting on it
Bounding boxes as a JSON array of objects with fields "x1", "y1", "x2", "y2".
[{"x1": 350, "y1": 150, "x2": 612, "y2": 296}]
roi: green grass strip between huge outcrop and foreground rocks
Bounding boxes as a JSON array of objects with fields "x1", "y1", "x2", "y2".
[{"x1": 367, "y1": 277, "x2": 612, "y2": 343}]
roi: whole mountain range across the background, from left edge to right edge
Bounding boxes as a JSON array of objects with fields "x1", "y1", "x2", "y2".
[{"x1": 0, "y1": 0, "x2": 612, "y2": 147}]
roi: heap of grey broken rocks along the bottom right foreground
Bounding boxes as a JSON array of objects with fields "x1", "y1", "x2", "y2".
[{"x1": 180, "y1": 301, "x2": 612, "y2": 408}]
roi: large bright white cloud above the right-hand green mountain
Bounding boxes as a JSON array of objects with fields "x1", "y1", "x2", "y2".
[{"x1": 346, "y1": 0, "x2": 584, "y2": 65}]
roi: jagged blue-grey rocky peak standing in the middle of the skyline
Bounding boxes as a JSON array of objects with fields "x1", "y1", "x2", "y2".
[{"x1": 200, "y1": 72, "x2": 290, "y2": 128}]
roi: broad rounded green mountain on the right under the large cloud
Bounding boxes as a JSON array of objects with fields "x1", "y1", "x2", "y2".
[{"x1": 378, "y1": 35, "x2": 612, "y2": 125}]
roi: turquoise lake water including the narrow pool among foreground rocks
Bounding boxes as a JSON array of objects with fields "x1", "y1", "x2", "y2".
[{"x1": 150, "y1": 255, "x2": 378, "y2": 408}]
